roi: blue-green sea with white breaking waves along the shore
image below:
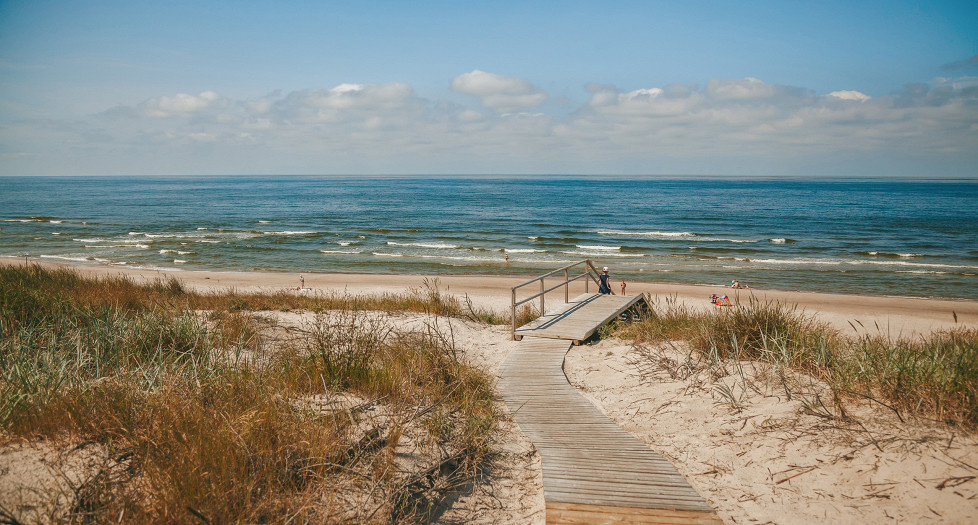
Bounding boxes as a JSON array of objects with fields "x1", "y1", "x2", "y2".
[{"x1": 0, "y1": 176, "x2": 978, "y2": 299}]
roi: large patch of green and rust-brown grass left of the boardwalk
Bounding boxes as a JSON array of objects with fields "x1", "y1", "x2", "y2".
[{"x1": 0, "y1": 266, "x2": 498, "y2": 523}]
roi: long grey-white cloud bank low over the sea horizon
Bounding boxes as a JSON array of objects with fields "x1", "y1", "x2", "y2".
[{"x1": 0, "y1": 70, "x2": 978, "y2": 177}]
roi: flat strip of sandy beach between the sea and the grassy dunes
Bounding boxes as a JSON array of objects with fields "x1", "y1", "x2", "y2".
[{"x1": 0, "y1": 258, "x2": 978, "y2": 337}]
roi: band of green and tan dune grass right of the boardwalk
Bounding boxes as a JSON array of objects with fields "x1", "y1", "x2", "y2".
[{"x1": 618, "y1": 292, "x2": 978, "y2": 430}]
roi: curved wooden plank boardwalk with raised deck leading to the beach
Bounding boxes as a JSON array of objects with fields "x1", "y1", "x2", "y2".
[{"x1": 499, "y1": 296, "x2": 722, "y2": 524}]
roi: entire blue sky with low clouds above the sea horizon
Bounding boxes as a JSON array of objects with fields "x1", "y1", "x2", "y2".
[{"x1": 0, "y1": 0, "x2": 978, "y2": 178}]
